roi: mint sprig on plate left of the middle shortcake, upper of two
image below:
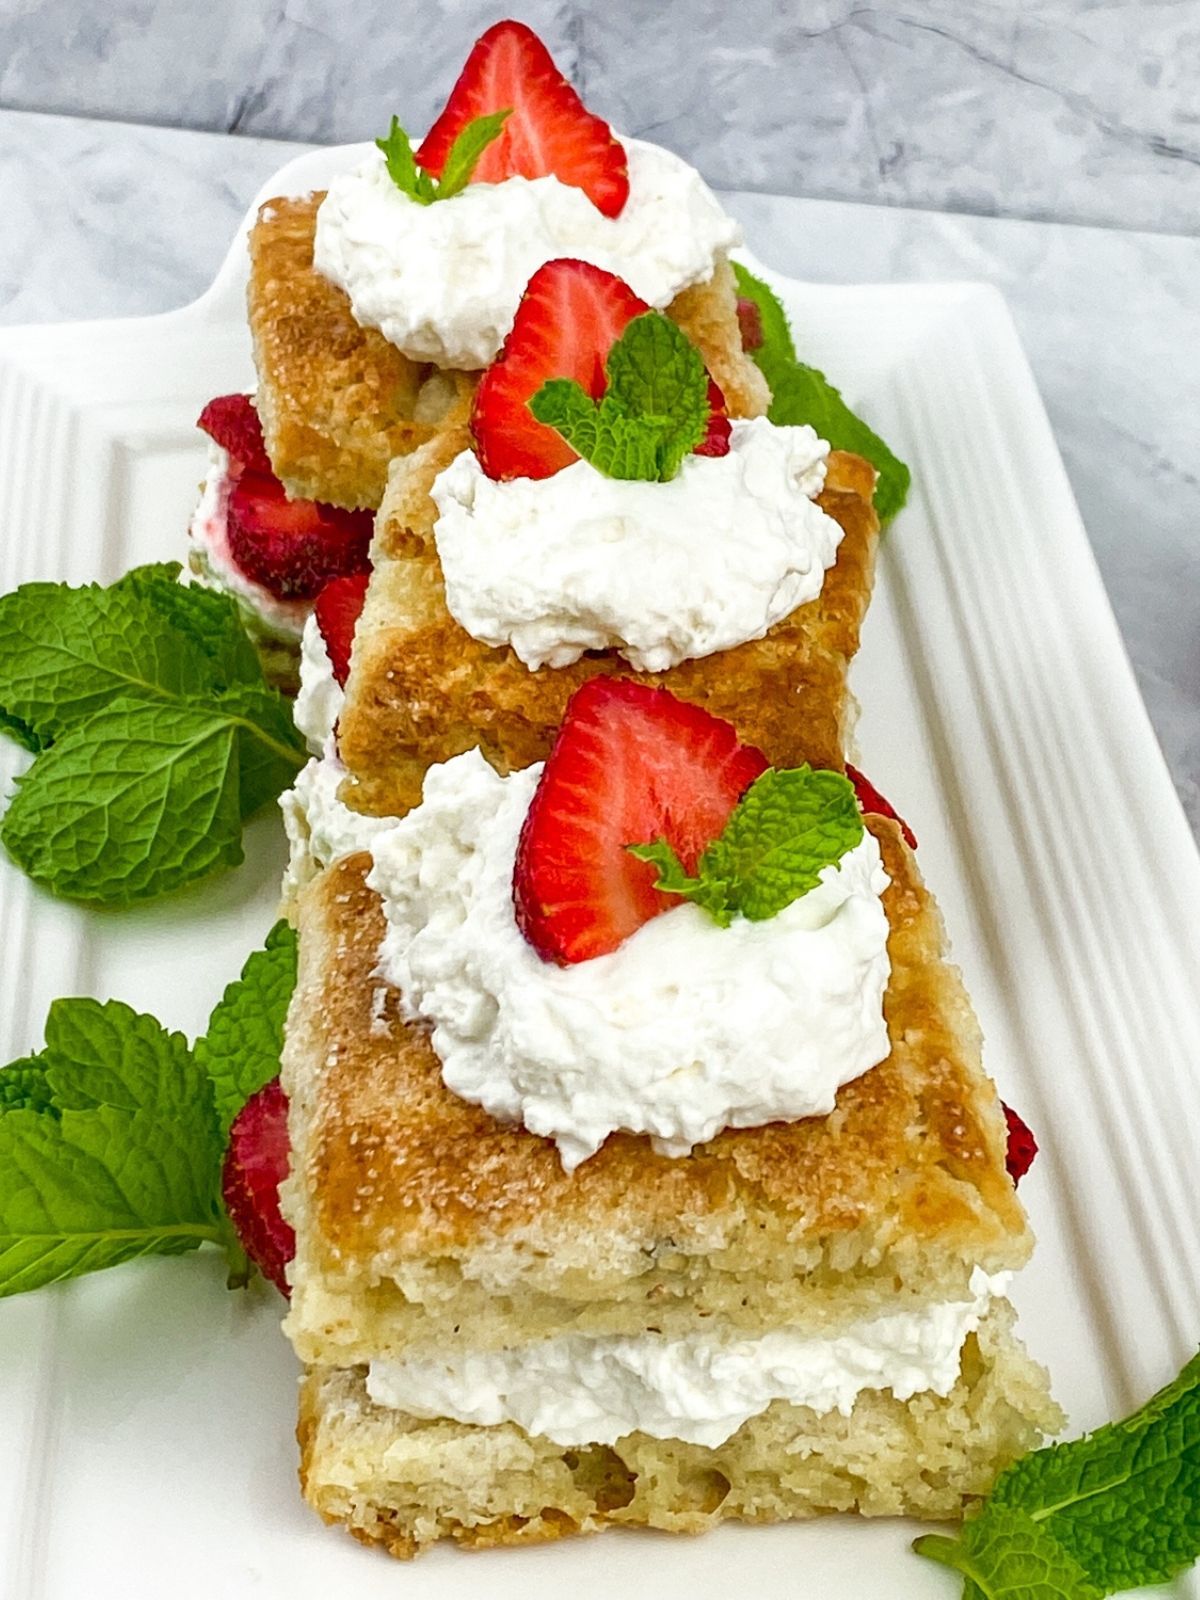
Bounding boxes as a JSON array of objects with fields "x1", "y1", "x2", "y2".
[{"x1": 0, "y1": 563, "x2": 306, "y2": 906}]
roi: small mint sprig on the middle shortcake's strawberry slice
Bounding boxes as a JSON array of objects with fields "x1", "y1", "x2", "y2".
[{"x1": 530, "y1": 310, "x2": 710, "y2": 483}]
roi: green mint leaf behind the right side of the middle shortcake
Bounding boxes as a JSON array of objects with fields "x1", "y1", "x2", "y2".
[{"x1": 733, "y1": 261, "x2": 912, "y2": 522}]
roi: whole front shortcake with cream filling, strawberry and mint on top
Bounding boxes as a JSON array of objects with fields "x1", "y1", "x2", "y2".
[{"x1": 282, "y1": 677, "x2": 1059, "y2": 1557}]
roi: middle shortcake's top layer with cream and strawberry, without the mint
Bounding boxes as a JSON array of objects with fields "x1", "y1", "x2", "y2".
[{"x1": 338, "y1": 261, "x2": 878, "y2": 814}]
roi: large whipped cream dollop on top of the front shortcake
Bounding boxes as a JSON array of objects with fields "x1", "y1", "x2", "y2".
[{"x1": 368, "y1": 750, "x2": 890, "y2": 1171}]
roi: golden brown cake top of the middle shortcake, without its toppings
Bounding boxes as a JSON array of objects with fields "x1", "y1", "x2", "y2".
[{"x1": 338, "y1": 429, "x2": 878, "y2": 816}]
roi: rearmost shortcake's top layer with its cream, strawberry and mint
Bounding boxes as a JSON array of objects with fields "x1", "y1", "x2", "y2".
[{"x1": 248, "y1": 21, "x2": 768, "y2": 507}]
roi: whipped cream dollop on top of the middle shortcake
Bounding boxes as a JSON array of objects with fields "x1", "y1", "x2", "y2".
[{"x1": 432, "y1": 418, "x2": 842, "y2": 672}]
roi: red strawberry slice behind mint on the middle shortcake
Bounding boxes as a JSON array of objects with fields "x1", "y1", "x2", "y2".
[{"x1": 470, "y1": 259, "x2": 730, "y2": 478}]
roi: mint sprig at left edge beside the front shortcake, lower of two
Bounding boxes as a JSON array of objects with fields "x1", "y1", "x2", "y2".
[{"x1": 0, "y1": 923, "x2": 296, "y2": 1298}]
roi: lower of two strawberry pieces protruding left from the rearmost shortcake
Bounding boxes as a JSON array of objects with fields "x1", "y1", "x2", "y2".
[{"x1": 227, "y1": 472, "x2": 374, "y2": 600}]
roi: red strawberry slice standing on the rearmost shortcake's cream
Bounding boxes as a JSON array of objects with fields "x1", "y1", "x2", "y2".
[{"x1": 416, "y1": 21, "x2": 629, "y2": 216}]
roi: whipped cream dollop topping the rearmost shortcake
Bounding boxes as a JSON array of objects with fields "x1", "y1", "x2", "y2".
[{"x1": 312, "y1": 139, "x2": 741, "y2": 368}]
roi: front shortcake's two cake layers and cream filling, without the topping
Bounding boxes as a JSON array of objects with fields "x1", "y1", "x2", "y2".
[{"x1": 283, "y1": 768, "x2": 1059, "y2": 1555}]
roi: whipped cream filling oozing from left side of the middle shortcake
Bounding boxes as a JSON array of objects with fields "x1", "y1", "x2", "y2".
[{"x1": 278, "y1": 616, "x2": 394, "y2": 898}]
